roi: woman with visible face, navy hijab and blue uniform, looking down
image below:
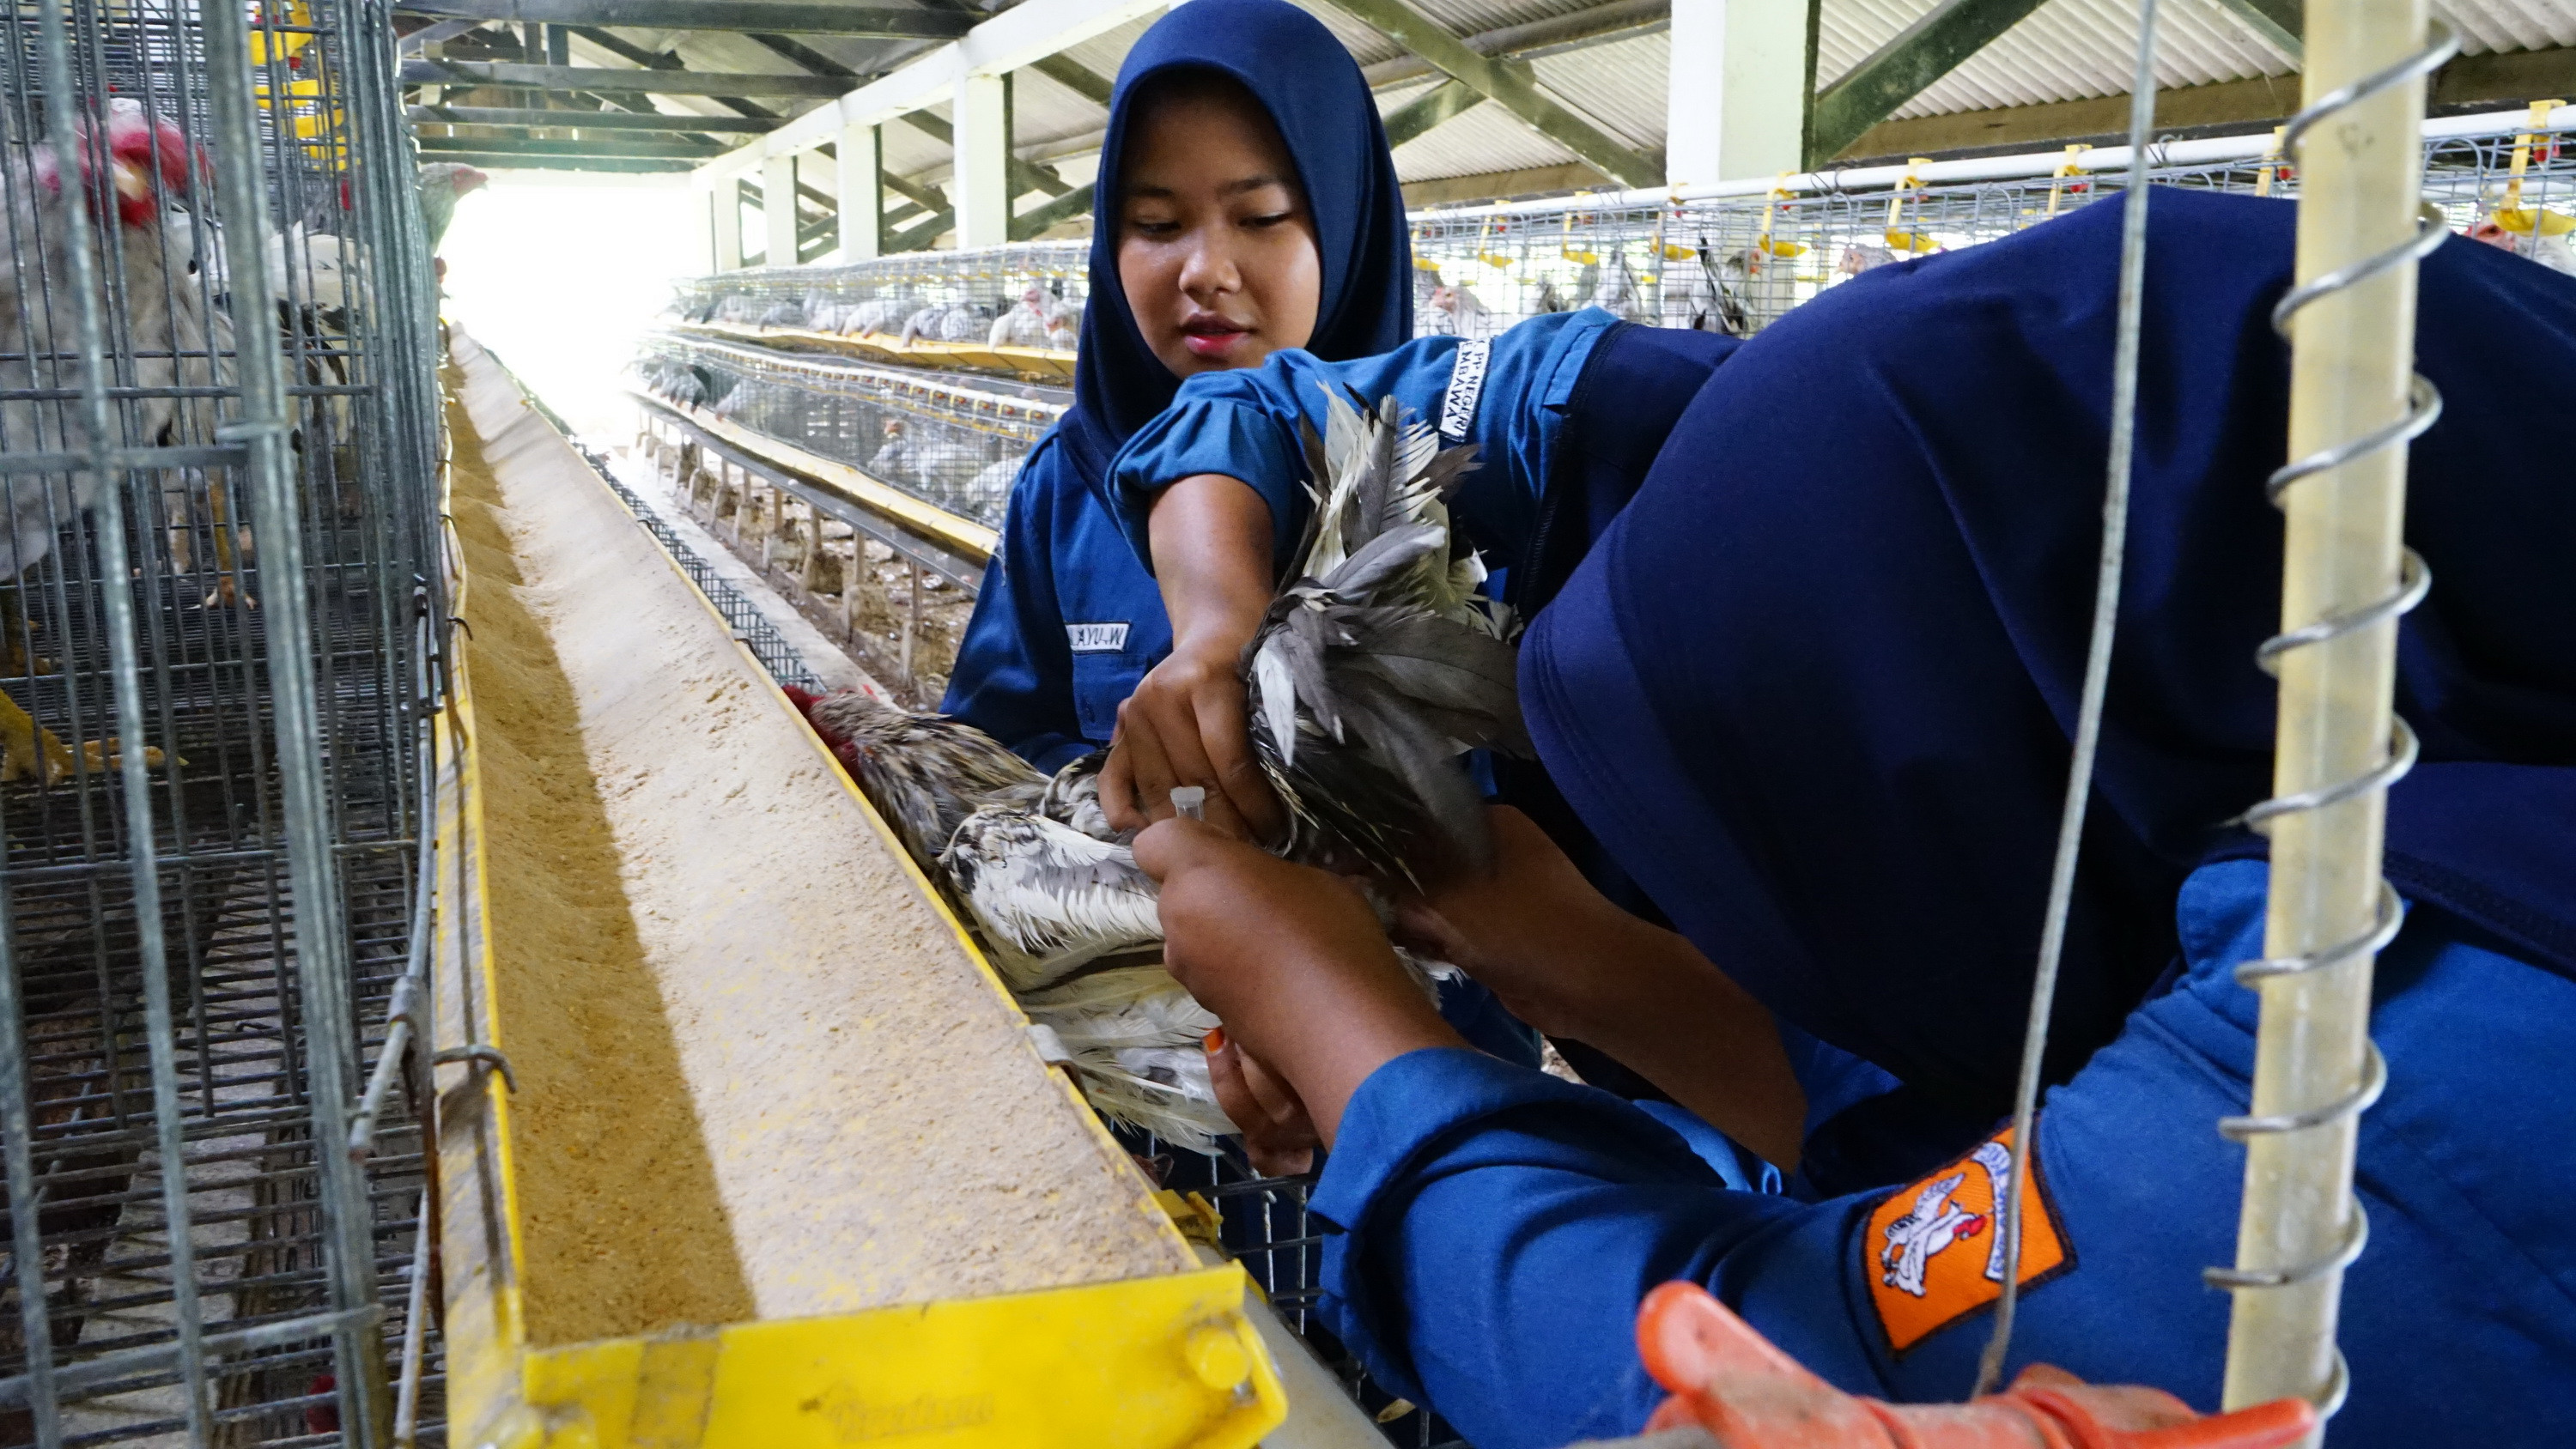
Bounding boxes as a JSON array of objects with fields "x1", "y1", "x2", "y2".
[{"x1": 943, "y1": 0, "x2": 1414, "y2": 769}]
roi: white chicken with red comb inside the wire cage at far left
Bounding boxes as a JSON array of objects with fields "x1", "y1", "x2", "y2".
[{"x1": 0, "y1": 103, "x2": 199, "y2": 785}]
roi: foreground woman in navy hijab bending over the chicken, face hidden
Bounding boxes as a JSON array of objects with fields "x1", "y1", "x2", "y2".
[{"x1": 1136, "y1": 191, "x2": 2576, "y2": 1449}]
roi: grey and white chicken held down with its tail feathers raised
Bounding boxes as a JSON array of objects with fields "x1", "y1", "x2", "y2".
[{"x1": 799, "y1": 399, "x2": 1528, "y2": 1148}]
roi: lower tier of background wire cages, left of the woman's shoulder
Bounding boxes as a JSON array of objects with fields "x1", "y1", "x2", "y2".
[{"x1": 636, "y1": 335, "x2": 1069, "y2": 528}]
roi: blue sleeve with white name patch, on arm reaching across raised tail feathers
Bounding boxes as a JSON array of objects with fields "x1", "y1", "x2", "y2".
[{"x1": 1110, "y1": 309, "x2": 1618, "y2": 569}]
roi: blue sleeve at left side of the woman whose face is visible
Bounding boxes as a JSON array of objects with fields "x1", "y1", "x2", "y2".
[{"x1": 940, "y1": 440, "x2": 1092, "y2": 772}]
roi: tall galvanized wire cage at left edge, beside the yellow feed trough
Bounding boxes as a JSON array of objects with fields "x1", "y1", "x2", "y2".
[{"x1": 0, "y1": 0, "x2": 446, "y2": 1446}]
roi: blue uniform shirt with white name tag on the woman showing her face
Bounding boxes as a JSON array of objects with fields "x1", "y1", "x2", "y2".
[{"x1": 940, "y1": 435, "x2": 1172, "y2": 772}]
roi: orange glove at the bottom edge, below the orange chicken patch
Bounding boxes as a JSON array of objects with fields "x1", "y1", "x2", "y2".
[{"x1": 1636, "y1": 1282, "x2": 2316, "y2": 1449}]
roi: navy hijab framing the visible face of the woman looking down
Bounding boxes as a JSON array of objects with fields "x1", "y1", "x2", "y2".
[{"x1": 1056, "y1": 0, "x2": 1414, "y2": 489}]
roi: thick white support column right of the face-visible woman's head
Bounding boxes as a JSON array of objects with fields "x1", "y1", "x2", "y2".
[{"x1": 1664, "y1": 0, "x2": 1806, "y2": 185}]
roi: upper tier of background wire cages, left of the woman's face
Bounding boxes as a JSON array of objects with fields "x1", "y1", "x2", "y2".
[{"x1": 670, "y1": 242, "x2": 1092, "y2": 348}]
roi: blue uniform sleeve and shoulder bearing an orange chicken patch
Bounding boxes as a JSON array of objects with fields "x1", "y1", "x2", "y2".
[{"x1": 1314, "y1": 862, "x2": 2576, "y2": 1449}]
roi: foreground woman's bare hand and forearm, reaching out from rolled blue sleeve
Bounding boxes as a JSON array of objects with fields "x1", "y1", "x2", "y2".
[{"x1": 1136, "y1": 818, "x2": 1466, "y2": 1145}]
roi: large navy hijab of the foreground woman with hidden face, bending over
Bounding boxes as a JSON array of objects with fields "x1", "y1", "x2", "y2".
[{"x1": 1522, "y1": 188, "x2": 2576, "y2": 1114}]
